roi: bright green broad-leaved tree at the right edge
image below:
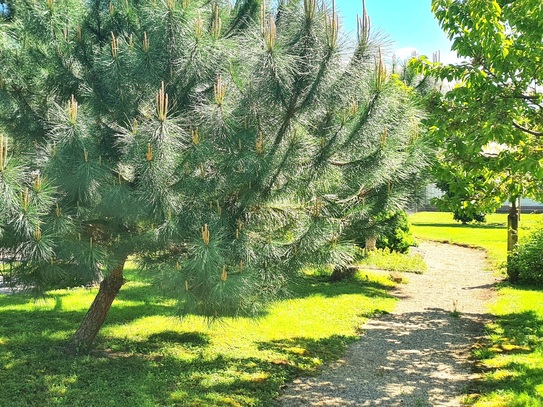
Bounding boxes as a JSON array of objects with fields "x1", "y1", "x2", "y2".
[{"x1": 413, "y1": 0, "x2": 543, "y2": 258}]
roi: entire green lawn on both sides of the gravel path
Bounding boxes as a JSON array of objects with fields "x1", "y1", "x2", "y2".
[{"x1": 4, "y1": 213, "x2": 543, "y2": 407}]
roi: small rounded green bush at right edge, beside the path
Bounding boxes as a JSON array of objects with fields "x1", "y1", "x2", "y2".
[{"x1": 507, "y1": 229, "x2": 543, "y2": 285}]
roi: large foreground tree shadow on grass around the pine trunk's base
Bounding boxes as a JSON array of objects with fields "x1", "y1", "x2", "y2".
[{"x1": 0, "y1": 321, "x2": 338, "y2": 407}]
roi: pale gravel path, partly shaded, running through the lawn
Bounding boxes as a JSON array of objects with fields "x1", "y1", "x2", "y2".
[{"x1": 278, "y1": 242, "x2": 495, "y2": 407}]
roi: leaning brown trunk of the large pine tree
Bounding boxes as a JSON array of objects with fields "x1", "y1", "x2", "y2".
[{"x1": 67, "y1": 258, "x2": 126, "y2": 353}]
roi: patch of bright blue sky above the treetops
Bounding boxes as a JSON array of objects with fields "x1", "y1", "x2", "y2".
[{"x1": 336, "y1": 0, "x2": 455, "y2": 63}]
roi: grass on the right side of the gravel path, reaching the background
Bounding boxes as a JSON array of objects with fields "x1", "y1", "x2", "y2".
[{"x1": 410, "y1": 212, "x2": 543, "y2": 407}]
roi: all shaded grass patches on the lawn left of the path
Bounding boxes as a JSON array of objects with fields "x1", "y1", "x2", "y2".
[{"x1": 0, "y1": 279, "x2": 400, "y2": 407}]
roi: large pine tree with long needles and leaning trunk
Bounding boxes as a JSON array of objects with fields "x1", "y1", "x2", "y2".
[{"x1": 0, "y1": 0, "x2": 434, "y2": 350}]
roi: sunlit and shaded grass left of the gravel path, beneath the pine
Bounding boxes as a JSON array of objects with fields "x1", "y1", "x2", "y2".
[{"x1": 0, "y1": 270, "x2": 395, "y2": 407}]
